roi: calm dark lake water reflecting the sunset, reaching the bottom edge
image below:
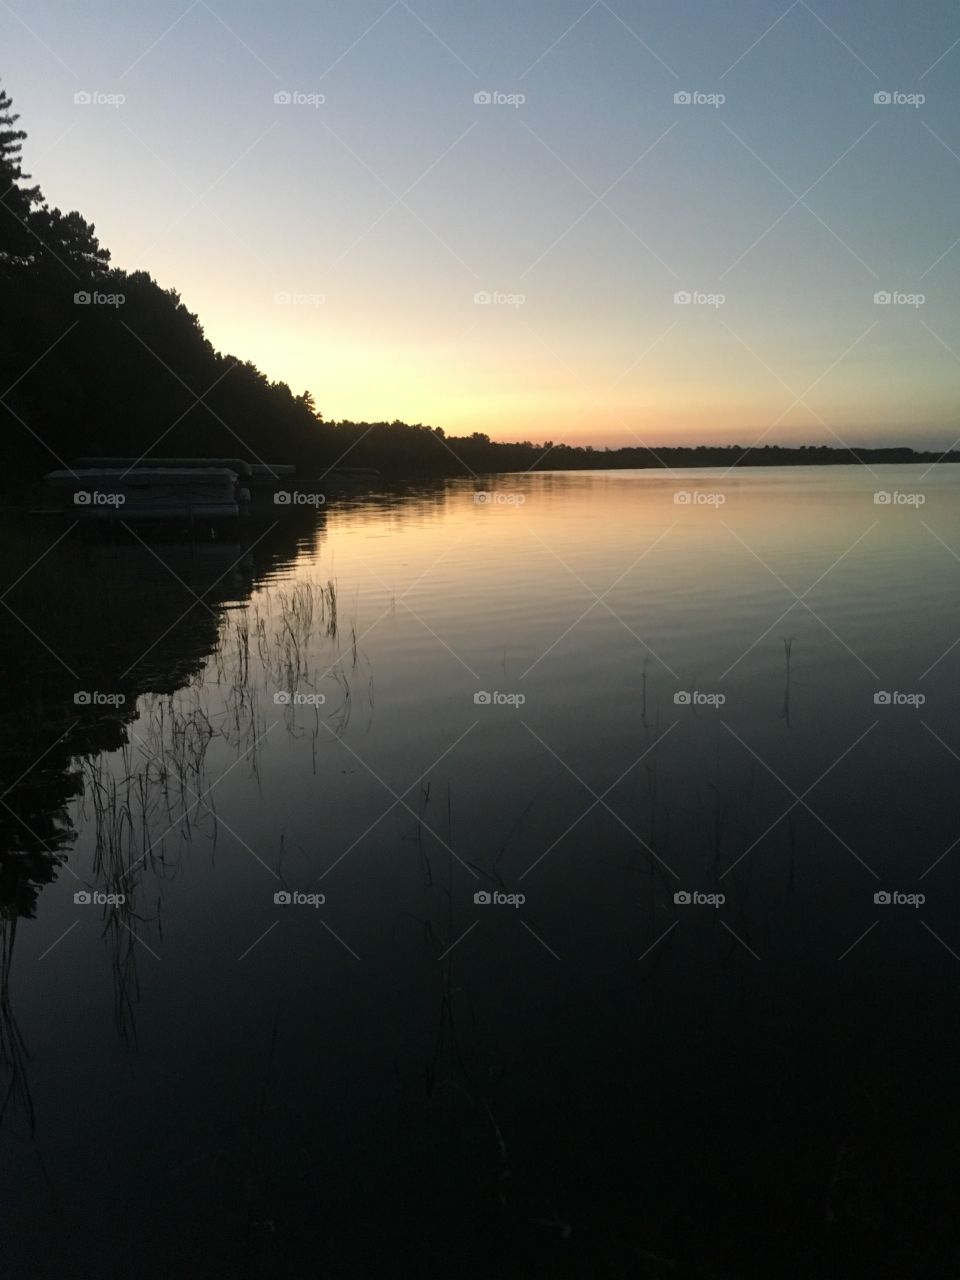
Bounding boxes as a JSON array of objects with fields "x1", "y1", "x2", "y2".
[{"x1": 0, "y1": 467, "x2": 960, "y2": 1277}]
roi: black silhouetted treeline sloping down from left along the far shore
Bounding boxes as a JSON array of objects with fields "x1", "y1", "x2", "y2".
[{"x1": 0, "y1": 80, "x2": 960, "y2": 485}]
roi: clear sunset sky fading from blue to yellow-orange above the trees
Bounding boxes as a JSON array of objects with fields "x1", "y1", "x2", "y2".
[{"x1": 0, "y1": 0, "x2": 960, "y2": 448}]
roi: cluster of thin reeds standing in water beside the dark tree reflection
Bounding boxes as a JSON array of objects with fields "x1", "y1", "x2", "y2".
[{"x1": 6, "y1": 577, "x2": 371, "y2": 1059}]
